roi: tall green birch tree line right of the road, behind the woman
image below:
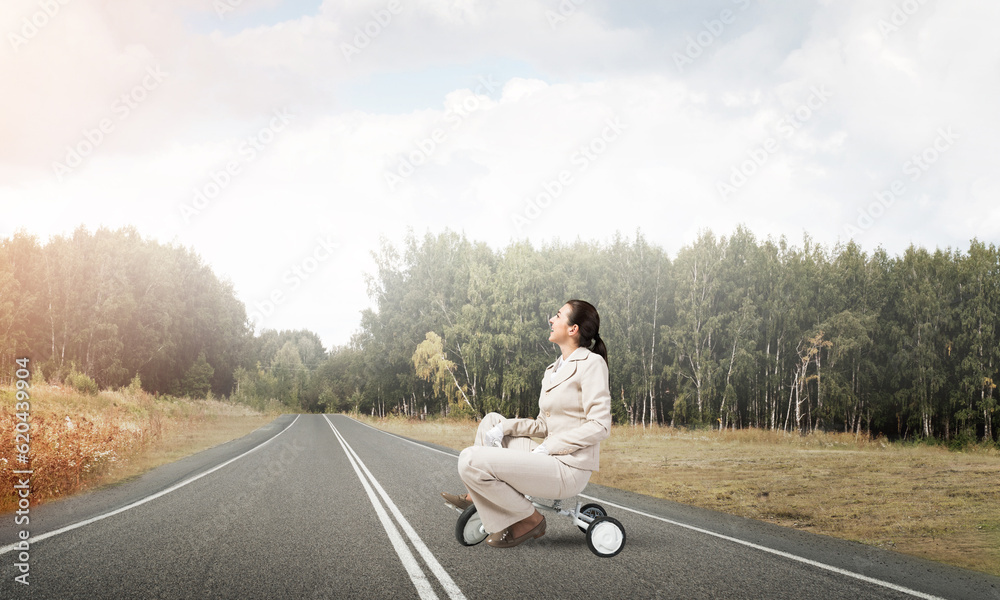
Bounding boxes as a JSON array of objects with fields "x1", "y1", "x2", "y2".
[{"x1": 326, "y1": 227, "x2": 1000, "y2": 440}]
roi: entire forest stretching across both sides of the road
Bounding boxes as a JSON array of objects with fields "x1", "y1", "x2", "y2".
[{"x1": 0, "y1": 227, "x2": 1000, "y2": 443}]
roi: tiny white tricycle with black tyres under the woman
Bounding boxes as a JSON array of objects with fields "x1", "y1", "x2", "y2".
[{"x1": 455, "y1": 496, "x2": 625, "y2": 558}]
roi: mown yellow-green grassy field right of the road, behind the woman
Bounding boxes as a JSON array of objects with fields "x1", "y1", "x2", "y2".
[{"x1": 361, "y1": 417, "x2": 1000, "y2": 575}]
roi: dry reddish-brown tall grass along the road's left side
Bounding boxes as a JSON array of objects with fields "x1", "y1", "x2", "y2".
[{"x1": 0, "y1": 385, "x2": 274, "y2": 512}]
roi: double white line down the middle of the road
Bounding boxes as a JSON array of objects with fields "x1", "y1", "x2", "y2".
[{"x1": 323, "y1": 415, "x2": 465, "y2": 600}]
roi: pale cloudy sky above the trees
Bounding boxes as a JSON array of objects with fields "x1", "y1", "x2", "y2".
[{"x1": 0, "y1": 0, "x2": 1000, "y2": 348}]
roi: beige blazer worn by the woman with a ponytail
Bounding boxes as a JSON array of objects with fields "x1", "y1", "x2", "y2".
[{"x1": 502, "y1": 348, "x2": 611, "y2": 471}]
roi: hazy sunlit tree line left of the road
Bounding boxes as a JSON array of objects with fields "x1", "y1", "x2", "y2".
[{"x1": 0, "y1": 228, "x2": 326, "y2": 410}]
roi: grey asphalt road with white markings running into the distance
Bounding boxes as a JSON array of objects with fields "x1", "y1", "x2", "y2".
[{"x1": 0, "y1": 415, "x2": 1000, "y2": 600}]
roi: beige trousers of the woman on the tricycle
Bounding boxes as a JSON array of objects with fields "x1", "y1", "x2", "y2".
[{"x1": 458, "y1": 413, "x2": 590, "y2": 533}]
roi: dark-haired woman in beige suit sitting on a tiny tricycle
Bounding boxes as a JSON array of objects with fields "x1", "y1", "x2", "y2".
[{"x1": 441, "y1": 300, "x2": 611, "y2": 548}]
